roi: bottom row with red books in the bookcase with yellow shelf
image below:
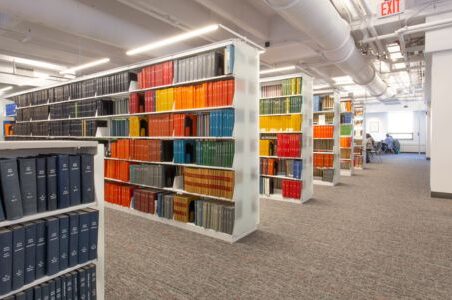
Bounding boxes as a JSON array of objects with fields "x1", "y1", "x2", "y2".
[{"x1": 259, "y1": 177, "x2": 303, "y2": 199}]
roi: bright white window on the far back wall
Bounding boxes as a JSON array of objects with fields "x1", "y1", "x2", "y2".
[{"x1": 388, "y1": 111, "x2": 414, "y2": 140}]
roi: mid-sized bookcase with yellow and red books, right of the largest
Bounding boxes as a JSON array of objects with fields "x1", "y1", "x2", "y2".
[{"x1": 259, "y1": 73, "x2": 313, "y2": 204}]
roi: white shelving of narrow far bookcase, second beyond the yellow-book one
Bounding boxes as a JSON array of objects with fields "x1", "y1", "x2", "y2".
[{"x1": 340, "y1": 97, "x2": 355, "y2": 176}]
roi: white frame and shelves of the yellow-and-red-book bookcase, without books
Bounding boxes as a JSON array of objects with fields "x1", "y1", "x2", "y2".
[{"x1": 259, "y1": 73, "x2": 313, "y2": 204}]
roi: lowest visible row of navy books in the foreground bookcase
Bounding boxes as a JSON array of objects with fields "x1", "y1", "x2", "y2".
[{"x1": 4, "y1": 264, "x2": 97, "y2": 300}]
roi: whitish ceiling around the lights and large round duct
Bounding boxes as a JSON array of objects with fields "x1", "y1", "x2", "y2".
[{"x1": 0, "y1": 0, "x2": 452, "y2": 105}]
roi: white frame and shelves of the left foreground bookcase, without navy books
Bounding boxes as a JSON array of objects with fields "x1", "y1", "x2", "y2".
[{"x1": 0, "y1": 141, "x2": 105, "y2": 299}]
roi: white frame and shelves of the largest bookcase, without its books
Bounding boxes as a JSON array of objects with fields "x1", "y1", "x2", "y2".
[{"x1": 5, "y1": 39, "x2": 259, "y2": 242}]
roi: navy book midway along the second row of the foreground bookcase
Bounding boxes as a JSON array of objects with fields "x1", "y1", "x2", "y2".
[{"x1": 45, "y1": 217, "x2": 60, "y2": 275}]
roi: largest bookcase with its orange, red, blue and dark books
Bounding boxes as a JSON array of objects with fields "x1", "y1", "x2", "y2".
[{"x1": 5, "y1": 39, "x2": 259, "y2": 243}]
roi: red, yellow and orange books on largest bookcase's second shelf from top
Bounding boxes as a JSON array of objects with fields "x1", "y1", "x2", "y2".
[{"x1": 129, "y1": 79, "x2": 234, "y2": 113}]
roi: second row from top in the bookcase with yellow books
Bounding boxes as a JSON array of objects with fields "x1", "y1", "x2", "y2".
[{"x1": 259, "y1": 96, "x2": 303, "y2": 115}]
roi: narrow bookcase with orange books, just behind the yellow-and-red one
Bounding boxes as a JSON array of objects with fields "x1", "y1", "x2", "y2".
[{"x1": 313, "y1": 91, "x2": 340, "y2": 186}]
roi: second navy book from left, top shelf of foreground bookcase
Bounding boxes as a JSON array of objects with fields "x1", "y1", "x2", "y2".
[{"x1": 17, "y1": 158, "x2": 38, "y2": 215}]
